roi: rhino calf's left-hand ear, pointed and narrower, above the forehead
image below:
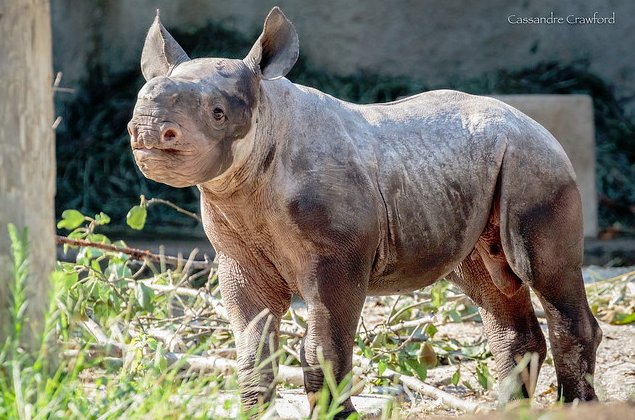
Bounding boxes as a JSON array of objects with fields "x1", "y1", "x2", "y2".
[{"x1": 141, "y1": 10, "x2": 190, "y2": 81}]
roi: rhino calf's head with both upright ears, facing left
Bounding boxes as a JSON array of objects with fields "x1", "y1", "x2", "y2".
[{"x1": 128, "y1": 7, "x2": 298, "y2": 187}]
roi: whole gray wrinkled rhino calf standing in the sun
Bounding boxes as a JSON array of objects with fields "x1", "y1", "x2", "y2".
[{"x1": 128, "y1": 8, "x2": 602, "y2": 412}]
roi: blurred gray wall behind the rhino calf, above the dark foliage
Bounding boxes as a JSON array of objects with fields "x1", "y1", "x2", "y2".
[{"x1": 52, "y1": 0, "x2": 635, "y2": 111}]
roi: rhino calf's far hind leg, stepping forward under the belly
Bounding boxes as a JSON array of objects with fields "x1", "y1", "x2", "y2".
[{"x1": 448, "y1": 253, "x2": 547, "y2": 403}]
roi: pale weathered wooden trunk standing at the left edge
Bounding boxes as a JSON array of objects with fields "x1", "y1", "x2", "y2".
[{"x1": 0, "y1": 0, "x2": 55, "y2": 344}]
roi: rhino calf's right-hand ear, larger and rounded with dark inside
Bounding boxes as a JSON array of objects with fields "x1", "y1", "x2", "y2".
[{"x1": 244, "y1": 6, "x2": 299, "y2": 80}]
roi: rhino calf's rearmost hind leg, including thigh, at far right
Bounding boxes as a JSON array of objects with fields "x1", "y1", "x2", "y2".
[{"x1": 501, "y1": 183, "x2": 602, "y2": 402}]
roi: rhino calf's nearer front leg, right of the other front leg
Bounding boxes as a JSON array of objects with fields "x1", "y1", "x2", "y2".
[{"x1": 301, "y1": 257, "x2": 370, "y2": 418}]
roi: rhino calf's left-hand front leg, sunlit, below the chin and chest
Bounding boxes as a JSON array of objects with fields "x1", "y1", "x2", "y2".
[{"x1": 218, "y1": 254, "x2": 291, "y2": 411}]
